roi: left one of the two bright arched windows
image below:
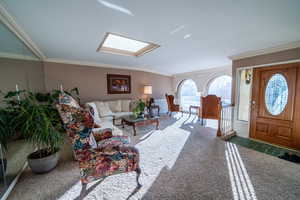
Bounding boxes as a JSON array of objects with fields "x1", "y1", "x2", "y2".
[{"x1": 179, "y1": 79, "x2": 200, "y2": 111}]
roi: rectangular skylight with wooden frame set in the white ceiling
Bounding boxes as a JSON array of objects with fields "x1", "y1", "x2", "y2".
[{"x1": 97, "y1": 33, "x2": 159, "y2": 56}]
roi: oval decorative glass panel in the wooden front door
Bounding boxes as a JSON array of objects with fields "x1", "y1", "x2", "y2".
[{"x1": 265, "y1": 74, "x2": 288, "y2": 115}]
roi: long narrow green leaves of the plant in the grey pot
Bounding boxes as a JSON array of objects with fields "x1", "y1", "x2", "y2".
[{"x1": 13, "y1": 92, "x2": 63, "y2": 152}]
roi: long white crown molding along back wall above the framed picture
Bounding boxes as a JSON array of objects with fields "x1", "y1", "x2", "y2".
[{"x1": 44, "y1": 58, "x2": 172, "y2": 76}]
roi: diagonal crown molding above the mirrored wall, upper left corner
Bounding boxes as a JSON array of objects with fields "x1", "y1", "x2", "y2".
[{"x1": 0, "y1": 4, "x2": 46, "y2": 60}]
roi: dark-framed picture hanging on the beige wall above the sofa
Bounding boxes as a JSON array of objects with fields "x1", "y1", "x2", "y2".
[{"x1": 107, "y1": 74, "x2": 131, "y2": 94}]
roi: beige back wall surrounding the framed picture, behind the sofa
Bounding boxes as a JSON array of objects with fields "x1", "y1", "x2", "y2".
[{"x1": 44, "y1": 62, "x2": 172, "y2": 102}]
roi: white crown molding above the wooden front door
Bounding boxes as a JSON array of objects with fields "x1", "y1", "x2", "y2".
[{"x1": 228, "y1": 41, "x2": 300, "y2": 60}]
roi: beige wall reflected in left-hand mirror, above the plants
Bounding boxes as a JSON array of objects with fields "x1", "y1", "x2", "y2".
[{"x1": 0, "y1": 58, "x2": 45, "y2": 92}]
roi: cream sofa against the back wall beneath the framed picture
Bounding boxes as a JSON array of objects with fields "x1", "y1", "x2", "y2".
[{"x1": 86, "y1": 100, "x2": 134, "y2": 135}]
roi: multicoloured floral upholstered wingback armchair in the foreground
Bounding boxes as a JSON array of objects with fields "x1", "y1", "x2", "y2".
[{"x1": 57, "y1": 93, "x2": 141, "y2": 186}]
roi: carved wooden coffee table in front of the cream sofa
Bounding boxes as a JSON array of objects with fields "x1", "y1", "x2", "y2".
[{"x1": 121, "y1": 115, "x2": 159, "y2": 136}]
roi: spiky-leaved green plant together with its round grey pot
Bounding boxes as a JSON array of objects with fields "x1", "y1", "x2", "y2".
[{"x1": 13, "y1": 92, "x2": 63, "y2": 173}]
